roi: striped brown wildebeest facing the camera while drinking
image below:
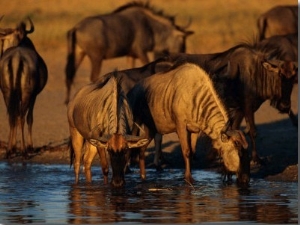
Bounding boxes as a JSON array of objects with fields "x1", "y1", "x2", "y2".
[{"x1": 68, "y1": 74, "x2": 148, "y2": 187}]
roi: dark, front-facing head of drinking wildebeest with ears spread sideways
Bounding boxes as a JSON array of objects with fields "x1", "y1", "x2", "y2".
[{"x1": 89, "y1": 133, "x2": 148, "y2": 187}]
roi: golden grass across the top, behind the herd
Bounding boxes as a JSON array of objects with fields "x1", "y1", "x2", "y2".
[{"x1": 0, "y1": 0, "x2": 297, "y2": 53}]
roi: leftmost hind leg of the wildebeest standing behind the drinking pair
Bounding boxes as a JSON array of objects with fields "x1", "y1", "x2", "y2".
[{"x1": 65, "y1": 51, "x2": 85, "y2": 104}]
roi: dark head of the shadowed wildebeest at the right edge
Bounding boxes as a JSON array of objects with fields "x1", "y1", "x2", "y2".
[{"x1": 263, "y1": 60, "x2": 298, "y2": 113}]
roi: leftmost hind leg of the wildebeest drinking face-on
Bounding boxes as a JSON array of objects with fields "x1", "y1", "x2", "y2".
[{"x1": 70, "y1": 127, "x2": 84, "y2": 184}]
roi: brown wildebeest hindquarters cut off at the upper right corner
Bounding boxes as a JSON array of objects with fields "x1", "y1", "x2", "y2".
[{"x1": 257, "y1": 5, "x2": 298, "y2": 40}]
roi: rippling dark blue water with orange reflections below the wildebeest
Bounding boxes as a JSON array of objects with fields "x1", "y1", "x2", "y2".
[{"x1": 0, "y1": 163, "x2": 298, "y2": 224}]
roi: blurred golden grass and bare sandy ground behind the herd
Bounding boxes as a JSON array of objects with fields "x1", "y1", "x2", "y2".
[{"x1": 0, "y1": 0, "x2": 298, "y2": 150}]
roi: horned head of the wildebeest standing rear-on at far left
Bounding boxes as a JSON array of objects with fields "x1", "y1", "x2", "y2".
[{"x1": 0, "y1": 18, "x2": 34, "y2": 55}]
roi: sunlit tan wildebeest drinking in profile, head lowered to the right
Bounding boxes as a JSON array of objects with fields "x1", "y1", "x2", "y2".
[{"x1": 128, "y1": 63, "x2": 250, "y2": 183}]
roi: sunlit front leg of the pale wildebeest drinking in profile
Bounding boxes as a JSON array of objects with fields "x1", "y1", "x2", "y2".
[{"x1": 177, "y1": 123, "x2": 194, "y2": 183}]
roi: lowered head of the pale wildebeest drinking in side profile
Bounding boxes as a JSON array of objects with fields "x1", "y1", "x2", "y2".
[{"x1": 215, "y1": 124, "x2": 250, "y2": 185}]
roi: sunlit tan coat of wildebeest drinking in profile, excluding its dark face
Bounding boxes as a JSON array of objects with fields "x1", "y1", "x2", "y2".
[{"x1": 128, "y1": 63, "x2": 245, "y2": 181}]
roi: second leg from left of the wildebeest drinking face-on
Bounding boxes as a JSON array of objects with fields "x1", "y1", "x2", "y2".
[{"x1": 83, "y1": 142, "x2": 97, "y2": 183}]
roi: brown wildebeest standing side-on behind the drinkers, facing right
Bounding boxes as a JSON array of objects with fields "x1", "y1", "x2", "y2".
[{"x1": 65, "y1": 2, "x2": 193, "y2": 103}]
